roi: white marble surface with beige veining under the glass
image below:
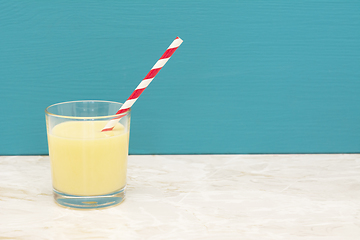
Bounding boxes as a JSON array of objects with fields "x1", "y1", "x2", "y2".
[{"x1": 0, "y1": 154, "x2": 360, "y2": 240}]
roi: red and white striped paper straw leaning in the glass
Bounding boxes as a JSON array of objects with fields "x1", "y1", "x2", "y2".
[{"x1": 101, "y1": 37, "x2": 183, "y2": 132}]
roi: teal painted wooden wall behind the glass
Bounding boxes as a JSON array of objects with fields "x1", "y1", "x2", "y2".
[{"x1": 0, "y1": 0, "x2": 360, "y2": 154}]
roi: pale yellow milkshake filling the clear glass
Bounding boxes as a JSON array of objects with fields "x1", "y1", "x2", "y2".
[{"x1": 48, "y1": 121, "x2": 129, "y2": 196}]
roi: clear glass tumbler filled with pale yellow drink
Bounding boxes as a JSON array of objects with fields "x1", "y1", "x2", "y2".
[{"x1": 45, "y1": 101, "x2": 130, "y2": 209}]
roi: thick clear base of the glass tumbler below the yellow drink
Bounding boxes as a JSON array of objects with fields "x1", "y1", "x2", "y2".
[{"x1": 53, "y1": 187, "x2": 126, "y2": 209}]
